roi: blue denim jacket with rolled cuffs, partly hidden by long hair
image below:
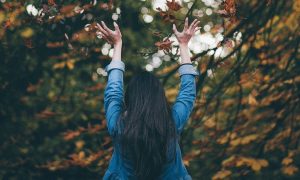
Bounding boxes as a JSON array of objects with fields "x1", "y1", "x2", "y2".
[{"x1": 103, "y1": 60, "x2": 199, "y2": 180}]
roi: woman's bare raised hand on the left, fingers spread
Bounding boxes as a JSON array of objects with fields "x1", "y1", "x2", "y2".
[{"x1": 97, "y1": 21, "x2": 122, "y2": 45}]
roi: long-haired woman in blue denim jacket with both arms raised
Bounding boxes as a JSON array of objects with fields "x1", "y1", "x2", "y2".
[{"x1": 97, "y1": 18, "x2": 200, "y2": 180}]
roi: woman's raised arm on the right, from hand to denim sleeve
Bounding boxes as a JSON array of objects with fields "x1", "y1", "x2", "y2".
[{"x1": 172, "y1": 18, "x2": 200, "y2": 134}]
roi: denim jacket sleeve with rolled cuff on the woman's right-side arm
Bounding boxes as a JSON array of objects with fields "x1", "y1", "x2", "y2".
[{"x1": 172, "y1": 64, "x2": 199, "y2": 134}]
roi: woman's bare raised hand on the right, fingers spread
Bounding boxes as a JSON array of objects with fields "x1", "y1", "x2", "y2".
[{"x1": 173, "y1": 18, "x2": 200, "y2": 45}]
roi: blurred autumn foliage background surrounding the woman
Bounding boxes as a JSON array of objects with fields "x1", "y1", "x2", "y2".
[{"x1": 0, "y1": 0, "x2": 300, "y2": 179}]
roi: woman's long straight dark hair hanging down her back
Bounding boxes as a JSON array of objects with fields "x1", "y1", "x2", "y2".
[{"x1": 118, "y1": 71, "x2": 177, "y2": 180}]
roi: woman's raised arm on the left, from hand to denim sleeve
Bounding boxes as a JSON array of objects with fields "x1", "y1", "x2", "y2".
[{"x1": 97, "y1": 21, "x2": 125, "y2": 135}]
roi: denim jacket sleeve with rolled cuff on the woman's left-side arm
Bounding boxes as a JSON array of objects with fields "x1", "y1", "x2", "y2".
[{"x1": 104, "y1": 60, "x2": 125, "y2": 135}]
